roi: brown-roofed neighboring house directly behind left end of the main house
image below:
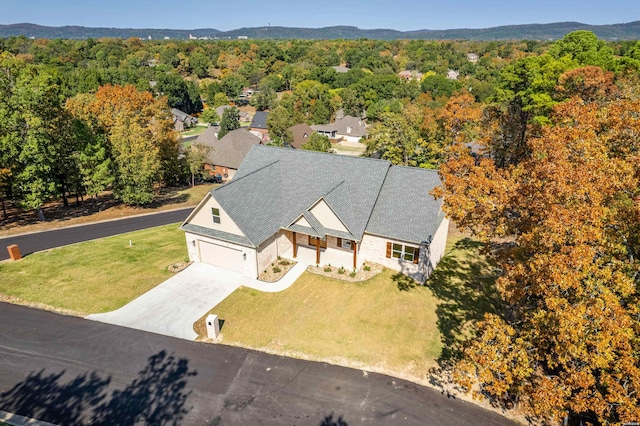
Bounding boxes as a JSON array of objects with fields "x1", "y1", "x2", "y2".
[{"x1": 196, "y1": 126, "x2": 260, "y2": 179}]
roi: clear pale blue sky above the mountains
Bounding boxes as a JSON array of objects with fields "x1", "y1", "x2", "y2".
[{"x1": 0, "y1": 0, "x2": 640, "y2": 31}]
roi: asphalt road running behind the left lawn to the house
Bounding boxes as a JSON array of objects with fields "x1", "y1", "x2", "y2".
[{"x1": 0, "y1": 207, "x2": 193, "y2": 260}]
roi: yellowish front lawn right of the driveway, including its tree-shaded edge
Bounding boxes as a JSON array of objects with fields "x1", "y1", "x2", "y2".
[{"x1": 195, "y1": 226, "x2": 495, "y2": 380}]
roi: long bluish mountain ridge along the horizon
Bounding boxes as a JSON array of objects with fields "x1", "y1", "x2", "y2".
[{"x1": 0, "y1": 21, "x2": 640, "y2": 41}]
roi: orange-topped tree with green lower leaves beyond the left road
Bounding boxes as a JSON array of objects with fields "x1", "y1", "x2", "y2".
[{"x1": 66, "y1": 85, "x2": 179, "y2": 204}]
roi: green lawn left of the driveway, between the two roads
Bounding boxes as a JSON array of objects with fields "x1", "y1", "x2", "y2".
[{"x1": 0, "y1": 223, "x2": 187, "y2": 315}]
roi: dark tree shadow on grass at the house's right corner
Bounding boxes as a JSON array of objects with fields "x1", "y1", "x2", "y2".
[{"x1": 425, "y1": 238, "x2": 501, "y2": 365}]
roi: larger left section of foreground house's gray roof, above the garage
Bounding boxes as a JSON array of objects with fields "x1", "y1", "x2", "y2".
[{"x1": 212, "y1": 146, "x2": 390, "y2": 245}]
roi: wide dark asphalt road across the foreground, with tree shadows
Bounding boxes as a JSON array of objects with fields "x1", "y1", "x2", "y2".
[{"x1": 0, "y1": 303, "x2": 514, "y2": 426}]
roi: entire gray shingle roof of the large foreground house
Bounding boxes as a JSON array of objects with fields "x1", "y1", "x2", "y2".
[{"x1": 183, "y1": 145, "x2": 444, "y2": 247}]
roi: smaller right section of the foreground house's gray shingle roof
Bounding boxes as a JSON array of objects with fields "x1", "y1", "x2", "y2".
[{"x1": 367, "y1": 166, "x2": 444, "y2": 243}]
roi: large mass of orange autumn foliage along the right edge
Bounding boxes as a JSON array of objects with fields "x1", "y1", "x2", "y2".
[{"x1": 436, "y1": 98, "x2": 640, "y2": 424}]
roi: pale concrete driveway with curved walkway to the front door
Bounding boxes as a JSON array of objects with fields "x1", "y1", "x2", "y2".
[{"x1": 86, "y1": 263, "x2": 306, "y2": 340}]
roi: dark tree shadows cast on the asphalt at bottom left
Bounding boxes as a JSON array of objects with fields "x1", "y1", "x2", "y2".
[{"x1": 0, "y1": 351, "x2": 197, "y2": 425}]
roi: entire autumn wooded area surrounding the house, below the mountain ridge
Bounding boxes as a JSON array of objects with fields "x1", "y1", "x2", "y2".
[{"x1": 0, "y1": 31, "x2": 640, "y2": 424}]
